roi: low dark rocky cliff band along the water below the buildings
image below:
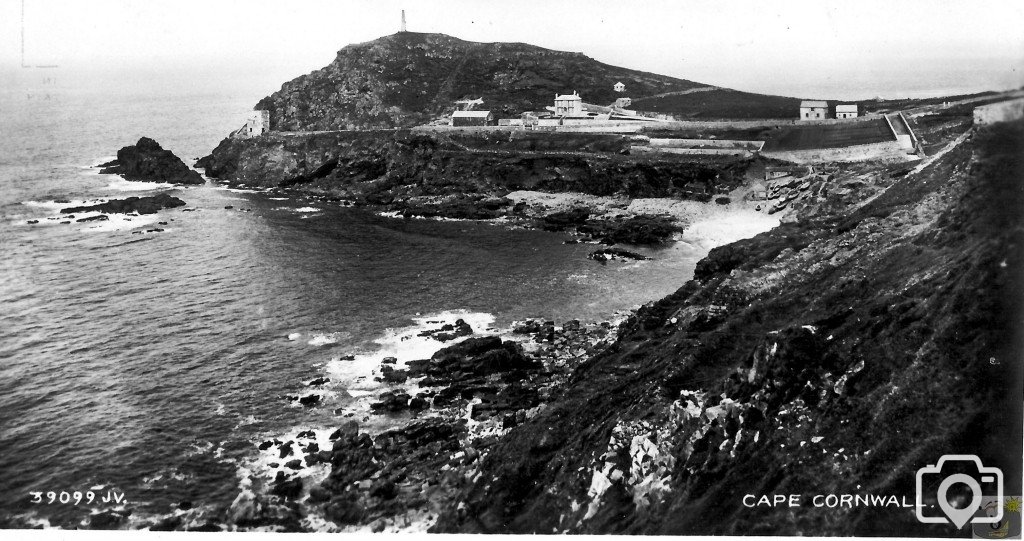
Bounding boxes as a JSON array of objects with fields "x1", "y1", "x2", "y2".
[{"x1": 197, "y1": 130, "x2": 761, "y2": 234}]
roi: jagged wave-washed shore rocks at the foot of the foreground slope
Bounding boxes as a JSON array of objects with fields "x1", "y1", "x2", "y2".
[{"x1": 145, "y1": 316, "x2": 625, "y2": 532}]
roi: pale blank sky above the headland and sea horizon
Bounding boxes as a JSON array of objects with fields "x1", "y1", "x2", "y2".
[{"x1": 0, "y1": 0, "x2": 1024, "y2": 98}]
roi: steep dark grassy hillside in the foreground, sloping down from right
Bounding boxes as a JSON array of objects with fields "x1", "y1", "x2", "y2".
[{"x1": 436, "y1": 123, "x2": 1024, "y2": 536}]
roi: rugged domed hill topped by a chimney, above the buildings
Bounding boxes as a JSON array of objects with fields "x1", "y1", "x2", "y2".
[{"x1": 256, "y1": 32, "x2": 703, "y2": 131}]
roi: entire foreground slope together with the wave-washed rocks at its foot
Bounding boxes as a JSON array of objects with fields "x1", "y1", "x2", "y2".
[{"x1": 174, "y1": 118, "x2": 1024, "y2": 536}]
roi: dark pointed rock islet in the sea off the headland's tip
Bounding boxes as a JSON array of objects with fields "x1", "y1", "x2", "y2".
[{"x1": 98, "y1": 137, "x2": 206, "y2": 184}]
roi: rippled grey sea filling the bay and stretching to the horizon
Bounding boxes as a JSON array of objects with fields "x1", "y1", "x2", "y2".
[{"x1": 0, "y1": 71, "x2": 729, "y2": 528}]
